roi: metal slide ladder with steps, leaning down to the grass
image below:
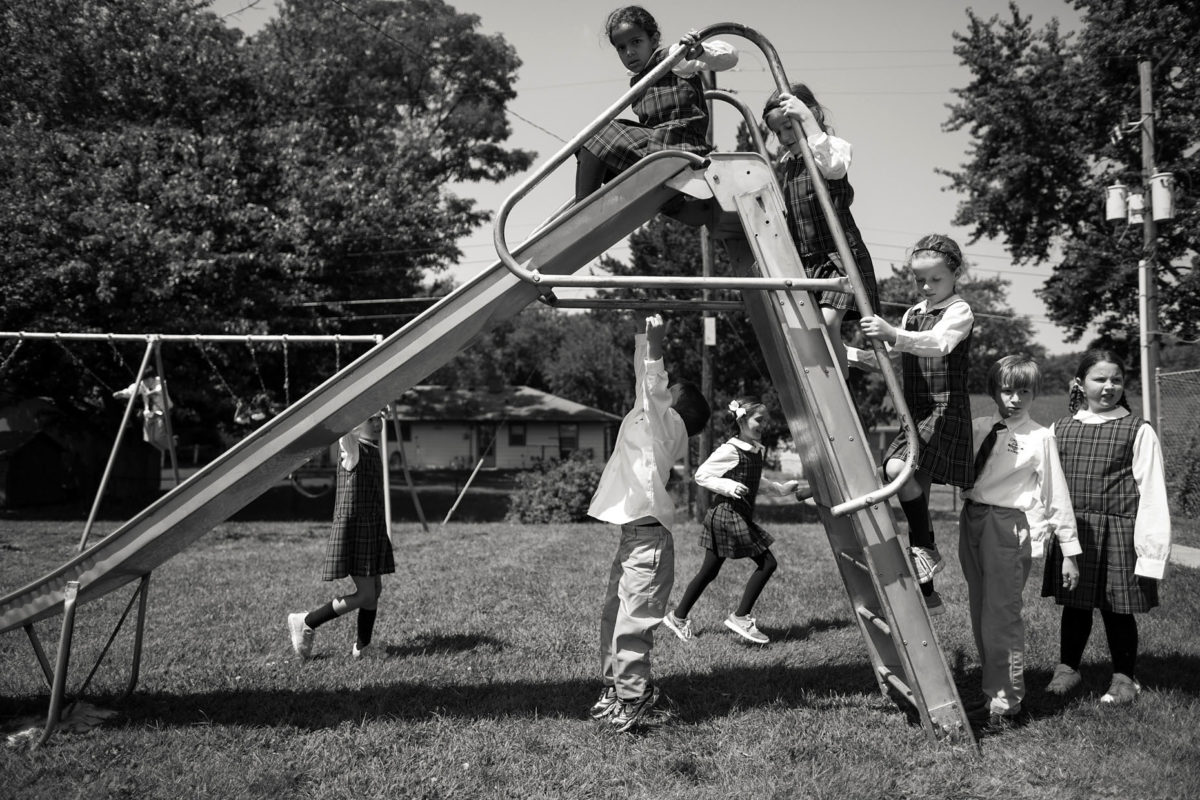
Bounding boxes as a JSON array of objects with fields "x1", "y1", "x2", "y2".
[{"x1": 706, "y1": 154, "x2": 972, "y2": 740}]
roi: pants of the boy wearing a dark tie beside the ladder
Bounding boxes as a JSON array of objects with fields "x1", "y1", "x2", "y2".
[{"x1": 959, "y1": 500, "x2": 1032, "y2": 714}]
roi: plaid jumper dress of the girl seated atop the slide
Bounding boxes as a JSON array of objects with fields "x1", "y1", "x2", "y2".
[{"x1": 583, "y1": 48, "x2": 713, "y2": 175}]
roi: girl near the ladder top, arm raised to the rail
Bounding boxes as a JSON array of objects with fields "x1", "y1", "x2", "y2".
[{"x1": 762, "y1": 83, "x2": 880, "y2": 372}]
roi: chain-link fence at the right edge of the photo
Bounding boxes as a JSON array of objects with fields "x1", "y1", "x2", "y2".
[{"x1": 1158, "y1": 369, "x2": 1200, "y2": 519}]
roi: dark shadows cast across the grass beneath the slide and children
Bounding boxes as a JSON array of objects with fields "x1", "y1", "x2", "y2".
[{"x1": 11, "y1": 652, "x2": 1200, "y2": 733}]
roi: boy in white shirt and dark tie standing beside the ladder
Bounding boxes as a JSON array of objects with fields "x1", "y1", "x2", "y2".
[{"x1": 959, "y1": 355, "x2": 1081, "y2": 724}]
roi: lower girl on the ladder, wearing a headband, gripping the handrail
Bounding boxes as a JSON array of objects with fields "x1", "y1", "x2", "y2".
[{"x1": 847, "y1": 234, "x2": 974, "y2": 615}]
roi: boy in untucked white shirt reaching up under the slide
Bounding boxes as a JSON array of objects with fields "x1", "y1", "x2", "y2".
[{"x1": 588, "y1": 314, "x2": 709, "y2": 733}]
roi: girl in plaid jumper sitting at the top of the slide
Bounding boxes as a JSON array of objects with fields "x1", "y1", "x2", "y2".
[{"x1": 575, "y1": 6, "x2": 738, "y2": 201}]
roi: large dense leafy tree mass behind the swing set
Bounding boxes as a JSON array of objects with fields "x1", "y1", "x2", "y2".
[{"x1": 0, "y1": 0, "x2": 530, "y2": 438}]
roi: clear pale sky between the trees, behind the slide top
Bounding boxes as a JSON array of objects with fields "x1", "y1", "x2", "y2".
[{"x1": 212, "y1": 0, "x2": 1089, "y2": 354}]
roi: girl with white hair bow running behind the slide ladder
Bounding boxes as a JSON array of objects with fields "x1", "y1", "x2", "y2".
[{"x1": 662, "y1": 397, "x2": 799, "y2": 644}]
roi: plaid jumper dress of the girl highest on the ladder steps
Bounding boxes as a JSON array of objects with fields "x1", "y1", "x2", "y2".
[{"x1": 782, "y1": 157, "x2": 880, "y2": 319}]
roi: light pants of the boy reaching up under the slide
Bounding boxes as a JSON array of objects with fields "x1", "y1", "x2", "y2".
[{"x1": 600, "y1": 525, "x2": 674, "y2": 700}]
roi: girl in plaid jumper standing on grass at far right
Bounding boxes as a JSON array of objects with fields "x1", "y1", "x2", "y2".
[{"x1": 1042, "y1": 350, "x2": 1171, "y2": 703}]
